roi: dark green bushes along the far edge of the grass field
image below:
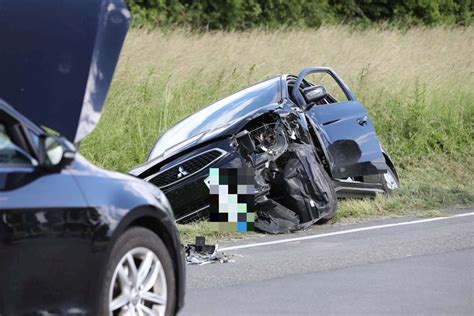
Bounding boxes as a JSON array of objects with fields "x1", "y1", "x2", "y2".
[{"x1": 128, "y1": 0, "x2": 473, "y2": 30}]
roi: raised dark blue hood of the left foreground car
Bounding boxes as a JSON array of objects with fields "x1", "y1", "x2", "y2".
[{"x1": 0, "y1": 0, "x2": 130, "y2": 143}]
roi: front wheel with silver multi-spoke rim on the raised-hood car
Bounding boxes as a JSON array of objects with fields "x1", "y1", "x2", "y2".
[{"x1": 99, "y1": 227, "x2": 176, "y2": 316}]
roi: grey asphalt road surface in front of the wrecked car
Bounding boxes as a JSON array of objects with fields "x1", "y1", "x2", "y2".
[{"x1": 180, "y1": 210, "x2": 474, "y2": 315}]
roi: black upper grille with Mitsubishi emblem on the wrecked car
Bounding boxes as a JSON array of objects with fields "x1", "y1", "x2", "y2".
[{"x1": 149, "y1": 149, "x2": 224, "y2": 188}]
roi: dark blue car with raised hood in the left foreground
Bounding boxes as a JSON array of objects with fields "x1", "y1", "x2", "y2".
[{"x1": 0, "y1": 0, "x2": 185, "y2": 316}]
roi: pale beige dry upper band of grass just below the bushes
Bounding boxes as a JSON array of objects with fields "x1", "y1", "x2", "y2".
[{"x1": 117, "y1": 26, "x2": 474, "y2": 91}]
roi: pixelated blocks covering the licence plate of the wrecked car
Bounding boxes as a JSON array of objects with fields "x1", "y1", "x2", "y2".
[{"x1": 206, "y1": 168, "x2": 255, "y2": 232}]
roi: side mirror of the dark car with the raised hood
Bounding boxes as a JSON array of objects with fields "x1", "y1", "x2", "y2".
[{"x1": 39, "y1": 135, "x2": 76, "y2": 169}]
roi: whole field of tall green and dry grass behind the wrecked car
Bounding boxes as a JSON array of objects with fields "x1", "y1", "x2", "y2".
[{"x1": 81, "y1": 27, "x2": 474, "y2": 231}]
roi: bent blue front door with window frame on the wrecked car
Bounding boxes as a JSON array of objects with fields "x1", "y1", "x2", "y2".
[{"x1": 293, "y1": 67, "x2": 387, "y2": 179}]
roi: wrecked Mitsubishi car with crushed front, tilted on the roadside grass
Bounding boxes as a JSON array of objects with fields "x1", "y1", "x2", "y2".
[{"x1": 131, "y1": 67, "x2": 399, "y2": 233}]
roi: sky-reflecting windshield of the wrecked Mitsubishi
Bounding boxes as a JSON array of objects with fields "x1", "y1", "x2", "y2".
[{"x1": 148, "y1": 77, "x2": 281, "y2": 160}]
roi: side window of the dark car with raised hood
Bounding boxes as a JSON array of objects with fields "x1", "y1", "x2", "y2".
[{"x1": 0, "y1": 124, "x2": 36, "y2": 166}]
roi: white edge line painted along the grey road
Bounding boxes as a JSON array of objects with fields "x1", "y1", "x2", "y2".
[{"x1": 218, "y1": 212, "x2": 474, "y2": 251}]
